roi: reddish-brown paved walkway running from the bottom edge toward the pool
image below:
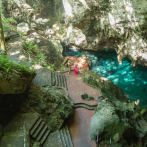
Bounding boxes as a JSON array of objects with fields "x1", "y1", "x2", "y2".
[{"x1": 64, "y1": 72, "x2": 100, "y2": 147}]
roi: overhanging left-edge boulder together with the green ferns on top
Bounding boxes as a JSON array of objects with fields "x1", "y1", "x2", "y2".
[{"x1": 0, "y1": 56, "x2": 36, "y2": 94}]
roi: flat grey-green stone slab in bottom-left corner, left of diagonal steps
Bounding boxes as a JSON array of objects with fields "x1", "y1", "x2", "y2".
[{"x1": 0, "y1": 113, "x2": 39, "y2": 147}]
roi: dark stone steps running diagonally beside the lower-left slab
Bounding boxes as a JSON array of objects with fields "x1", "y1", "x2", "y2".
[{"x1": 30, "y1": 117, "x2": 50, "y2": 145}]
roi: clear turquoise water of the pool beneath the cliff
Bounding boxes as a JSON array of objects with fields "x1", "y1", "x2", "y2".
[{"x1": 63, "y1": 49, "x2": 147, "y2": 107}]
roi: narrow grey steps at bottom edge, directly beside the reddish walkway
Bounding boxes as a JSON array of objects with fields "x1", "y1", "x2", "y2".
[{"x1": 59, "y1": 125, "x2": 73, "y2": 147}]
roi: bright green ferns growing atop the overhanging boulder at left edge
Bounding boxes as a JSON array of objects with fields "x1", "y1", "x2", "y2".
[{"x1": 0, "y1": 51, "x2": 35, "y2": 73}]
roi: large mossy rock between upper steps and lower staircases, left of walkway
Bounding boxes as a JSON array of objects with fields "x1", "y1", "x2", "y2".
[{"x1": 28, "y1": 84, "x2": 74, "y2": 131}]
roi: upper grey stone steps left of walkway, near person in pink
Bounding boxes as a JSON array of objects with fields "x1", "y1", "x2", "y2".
[{"x1": 51, "y1": 72, "x2": 67, "y2": 89}]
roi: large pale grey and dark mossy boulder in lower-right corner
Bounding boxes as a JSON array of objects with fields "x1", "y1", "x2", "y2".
[{"x1": 90, "y1": 99, "x2": 147, "y2": 147}]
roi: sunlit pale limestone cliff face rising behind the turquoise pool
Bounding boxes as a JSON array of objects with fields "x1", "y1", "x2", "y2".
[{"x1": 2, "y1": 0, "x2": 147, "y2": 66}]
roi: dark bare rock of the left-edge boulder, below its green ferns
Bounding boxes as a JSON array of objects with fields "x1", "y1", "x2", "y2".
[{"x1": 0, "y1": 67, "x2": 35, "y2": 94}]
